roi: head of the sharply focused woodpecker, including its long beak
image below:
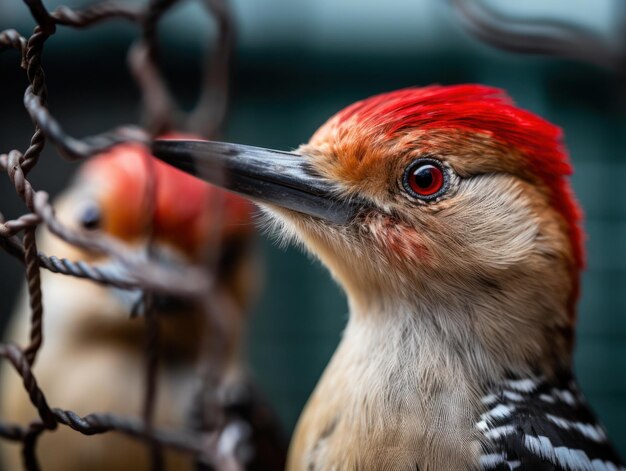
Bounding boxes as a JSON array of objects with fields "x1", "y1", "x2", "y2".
[{"x1": 154, "y1": 85, "x2": 583, "y2": 372}]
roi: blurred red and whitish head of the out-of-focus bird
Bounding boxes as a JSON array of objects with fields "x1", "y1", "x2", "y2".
[{"x1": 58, "y1": 140, "x2": 253, "y2": 300}]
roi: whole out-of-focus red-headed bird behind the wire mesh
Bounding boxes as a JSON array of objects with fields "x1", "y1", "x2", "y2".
[{"x1": 0, "y1": 144, "x2": 287, "y2": 471}]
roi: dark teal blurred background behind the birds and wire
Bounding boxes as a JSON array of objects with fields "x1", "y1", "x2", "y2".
[{"x1": 0, "y1": 0, "x2": 626, "y2": 455}]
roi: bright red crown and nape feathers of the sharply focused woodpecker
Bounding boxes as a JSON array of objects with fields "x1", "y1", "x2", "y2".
[{"x1": 311, "y1": 85, "x2": 584, "y2": 282}]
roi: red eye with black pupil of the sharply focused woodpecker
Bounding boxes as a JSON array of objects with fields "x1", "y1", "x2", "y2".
[{"x1": 402, "y1": 158, "x2": 449, "y2": 201}]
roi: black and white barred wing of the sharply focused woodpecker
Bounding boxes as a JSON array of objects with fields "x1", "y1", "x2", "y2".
[{"x1": 476, "y1": 374, "x2": 626, "y2": 471}]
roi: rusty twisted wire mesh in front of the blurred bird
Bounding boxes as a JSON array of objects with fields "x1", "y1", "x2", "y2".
[{"x1": 0, "y1": 0, "x2": 243, "y2": 470}]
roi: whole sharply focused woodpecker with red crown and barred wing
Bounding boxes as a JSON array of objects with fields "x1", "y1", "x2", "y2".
[{"x1": 153, "y1": 85, "x2": 626, "y2": 471}]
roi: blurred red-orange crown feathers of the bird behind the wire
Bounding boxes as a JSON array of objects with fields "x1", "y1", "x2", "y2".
[{"x1": 80, "y1": 144, "x2": 253, "y2": 254}]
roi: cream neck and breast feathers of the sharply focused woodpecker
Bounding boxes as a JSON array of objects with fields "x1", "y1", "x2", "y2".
[{"x1": 289, "y1": 307, "x2": 576, "y2": 470}]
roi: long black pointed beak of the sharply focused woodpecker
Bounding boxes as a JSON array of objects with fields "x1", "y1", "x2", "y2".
[{"x1": 152, "y1": 140, "x2": 362, "y2": 224}]
